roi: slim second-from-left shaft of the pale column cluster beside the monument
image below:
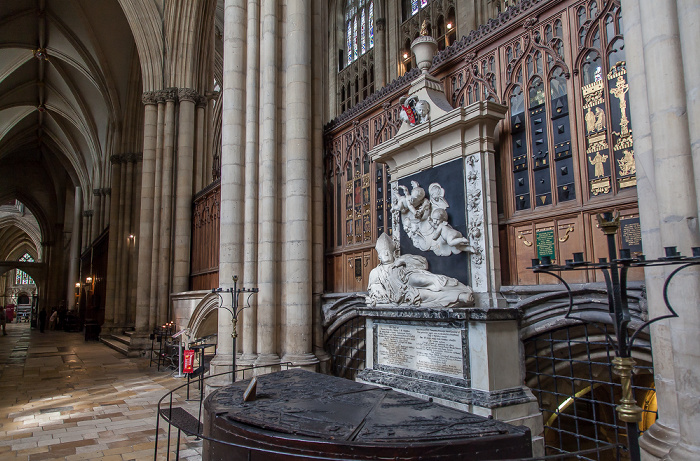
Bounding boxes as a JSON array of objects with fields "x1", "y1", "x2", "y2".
[{"x1": 242, "y1": 0, "x2": 260, "y2": 365}]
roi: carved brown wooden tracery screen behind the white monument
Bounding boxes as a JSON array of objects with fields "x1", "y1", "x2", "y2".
[{"x1": 326, "y1": 0, "x2": 642, "y2": 291}]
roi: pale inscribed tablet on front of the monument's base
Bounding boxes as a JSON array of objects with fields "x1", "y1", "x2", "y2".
[{"x1": 376, "y1": 323, "x2": 464, "y2": 379}]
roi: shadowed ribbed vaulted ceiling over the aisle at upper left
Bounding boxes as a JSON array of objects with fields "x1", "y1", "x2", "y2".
[{"x1": 0, "y1": 0, "x2": 142, "y2": 252}]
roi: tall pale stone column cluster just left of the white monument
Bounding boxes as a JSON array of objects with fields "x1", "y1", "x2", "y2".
[{"x1": 212, "y1": 0, "x2": 325, "y2": 371}]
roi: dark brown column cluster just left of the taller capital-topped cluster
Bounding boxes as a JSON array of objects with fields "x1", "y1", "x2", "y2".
[{"x1": 102, "y1": 153, "x2": 142, "y2": 332}]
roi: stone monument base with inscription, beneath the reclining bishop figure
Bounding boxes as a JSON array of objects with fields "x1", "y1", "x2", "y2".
[{"x1": 357, "y1": 306, "x2": 544, "y2": 456}]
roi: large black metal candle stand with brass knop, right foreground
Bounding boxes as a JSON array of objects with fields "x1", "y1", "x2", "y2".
[{"x1": 528, "y1": 213, "x2": 700, "y2": 461}]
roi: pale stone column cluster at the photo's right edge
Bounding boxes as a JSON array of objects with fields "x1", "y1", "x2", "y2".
[{"x1": 622, "y1": 0, "x2": 700, "y2": 460}]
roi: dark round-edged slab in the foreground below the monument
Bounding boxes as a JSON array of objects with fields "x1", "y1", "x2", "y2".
[{"x1": 203, "y1": 369, "x2": 532, "y2": 461}]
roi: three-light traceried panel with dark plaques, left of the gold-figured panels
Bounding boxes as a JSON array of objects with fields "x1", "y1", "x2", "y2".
[{"x1": 504, "y1": 17, "x2": 576, "y2": 211}]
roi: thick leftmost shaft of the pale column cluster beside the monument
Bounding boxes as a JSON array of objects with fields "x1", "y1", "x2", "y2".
[{"x1": 212, "y1": 0, "x2": 247, "y2": 373}]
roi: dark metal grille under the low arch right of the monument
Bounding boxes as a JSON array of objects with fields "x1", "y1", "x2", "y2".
[{"x1": 524, "y1": 325, "x2": 657, "y2": 460}]
